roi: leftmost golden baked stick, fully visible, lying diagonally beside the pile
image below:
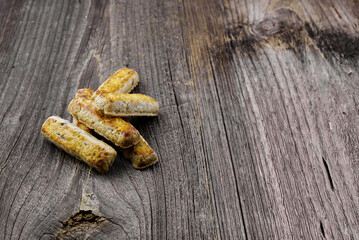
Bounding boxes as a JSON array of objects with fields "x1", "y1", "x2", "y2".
[{"x1": 41, "y1": 116, "x2": 117, "y2": 173}]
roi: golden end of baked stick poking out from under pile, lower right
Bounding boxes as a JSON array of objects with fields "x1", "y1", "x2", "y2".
[{"x1": 121, "y1": 136, "x2": 158, "y2": 169}]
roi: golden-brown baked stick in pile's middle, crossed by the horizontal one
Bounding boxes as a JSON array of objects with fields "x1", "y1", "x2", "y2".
[{"x1": 68, "y1": 89, "x2": 140, "y2": 148}]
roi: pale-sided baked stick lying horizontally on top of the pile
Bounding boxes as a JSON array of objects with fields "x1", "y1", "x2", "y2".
[{"x1": 93, "y1": 93, "x2": 159, "y2": 117}]
